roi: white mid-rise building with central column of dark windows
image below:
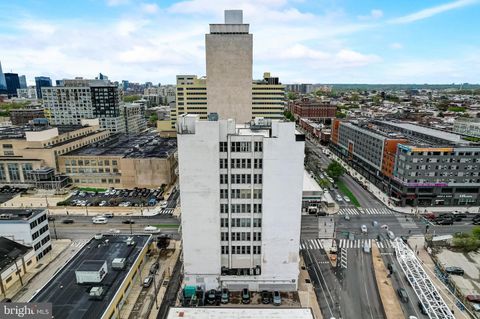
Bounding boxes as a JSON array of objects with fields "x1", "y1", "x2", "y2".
[{"x1": 177, "y1": 114, "x2": 305, "y2": 291}]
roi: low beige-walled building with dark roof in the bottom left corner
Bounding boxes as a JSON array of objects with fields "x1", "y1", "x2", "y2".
[{"x1": 0, "y1": 237, "x2": 37, "y2": 296}]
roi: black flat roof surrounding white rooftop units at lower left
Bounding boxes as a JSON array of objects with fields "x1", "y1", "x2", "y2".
[{"x1": 30, "y1": 235, "x2": 151, "y2": 319}]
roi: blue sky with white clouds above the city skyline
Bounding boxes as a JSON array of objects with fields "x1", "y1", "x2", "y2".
[{"x1": 0, "y1": 0, "x2": 480, "y2": 84}]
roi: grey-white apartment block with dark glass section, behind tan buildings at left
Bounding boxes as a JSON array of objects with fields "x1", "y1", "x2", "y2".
[{"x1": 42, "y1": 79, "x2": 146, "y2": 133}]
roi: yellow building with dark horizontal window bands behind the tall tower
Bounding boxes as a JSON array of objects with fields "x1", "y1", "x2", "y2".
[{"x1": 170, "y1": 72, "x2": 285, "y2": 129}]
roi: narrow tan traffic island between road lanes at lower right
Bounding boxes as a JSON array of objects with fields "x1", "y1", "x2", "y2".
[{"x1": 372, "y1": 245, "x2": 404, "y2": 319}]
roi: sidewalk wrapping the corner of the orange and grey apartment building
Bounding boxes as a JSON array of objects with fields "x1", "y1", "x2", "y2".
[{"x1": 330, "y1": 152, "x2": 480, "y2": 215}]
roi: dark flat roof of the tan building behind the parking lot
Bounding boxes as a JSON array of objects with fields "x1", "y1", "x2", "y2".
[{"x1": 64, "y1": 133, "x2": 177, "y2": 158}]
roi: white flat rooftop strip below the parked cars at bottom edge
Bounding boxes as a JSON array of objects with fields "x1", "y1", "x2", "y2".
[{"x1": 167, "y1": 307, "x2": 314, "y2": 319}]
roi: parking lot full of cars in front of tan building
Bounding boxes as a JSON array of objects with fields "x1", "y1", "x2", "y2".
[{"x1": 57, "y1": 188, "x2": 166, "y2": 207}]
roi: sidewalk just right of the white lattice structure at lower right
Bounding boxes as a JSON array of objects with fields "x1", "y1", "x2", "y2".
[{"x1": 408, "y1": 236, "x2": 470, "y2": 319}]
